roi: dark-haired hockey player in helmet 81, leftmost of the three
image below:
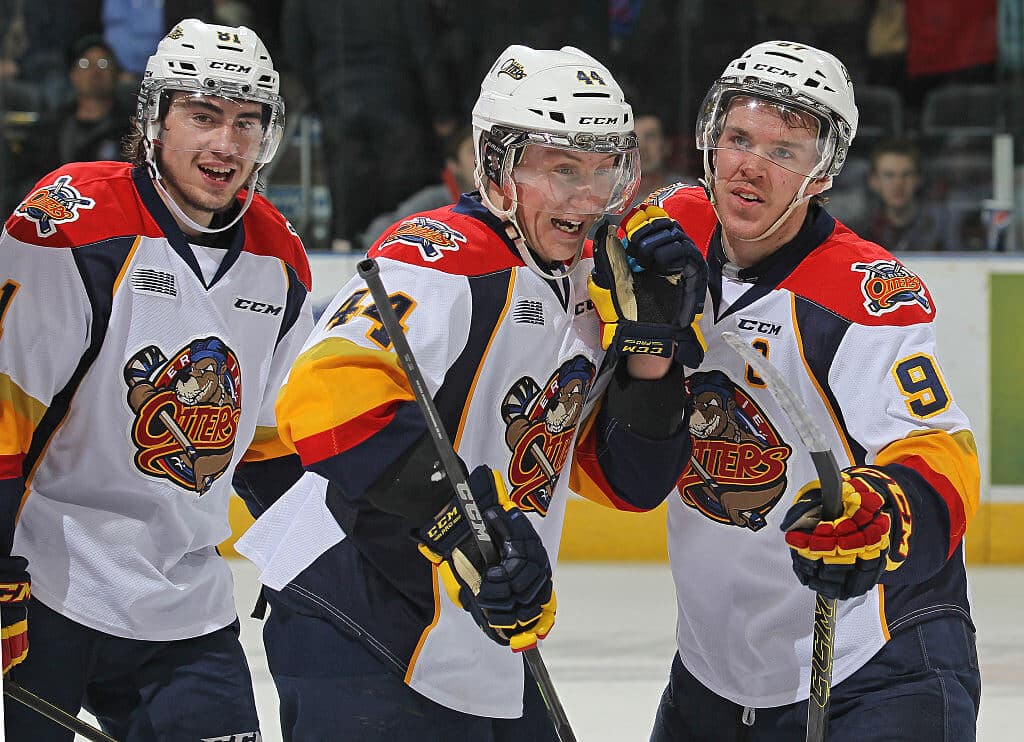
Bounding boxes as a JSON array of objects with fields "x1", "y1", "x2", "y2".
[{"x1": 0, "y1": 18, "x2": 312, "y2": 742}]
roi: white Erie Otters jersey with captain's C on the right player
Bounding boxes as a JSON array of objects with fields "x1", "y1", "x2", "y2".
[{"x1": 630, "y1": 185, "x2": 979, "y2": 707}]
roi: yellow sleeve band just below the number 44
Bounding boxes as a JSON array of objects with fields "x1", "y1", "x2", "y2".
[{"x1": 274, "y1": 338, "x2": 414, "y2": 452}]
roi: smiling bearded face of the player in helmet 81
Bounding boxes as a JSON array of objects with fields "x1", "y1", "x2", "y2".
[{"x1": 157, "y1": 94, "x2": 263, "y2": 225}]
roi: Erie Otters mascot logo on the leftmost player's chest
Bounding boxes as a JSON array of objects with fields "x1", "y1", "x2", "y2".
[{"x1": 124, "y1": 338, "x2": 242, "y2": 496}]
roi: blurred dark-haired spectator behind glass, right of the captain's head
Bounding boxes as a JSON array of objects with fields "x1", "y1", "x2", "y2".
[{"x1": 854, "y1": 140, "x2": 958, "y2": 253}]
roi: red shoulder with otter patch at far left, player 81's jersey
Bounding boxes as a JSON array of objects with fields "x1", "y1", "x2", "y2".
[{"x1": 6, "y1": 162, "x2": 160, "y2": 248}]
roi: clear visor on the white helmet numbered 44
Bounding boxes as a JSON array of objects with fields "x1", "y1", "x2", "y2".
[{"x1": 502, "y1": 142, "x2": 640, "y2": 216}]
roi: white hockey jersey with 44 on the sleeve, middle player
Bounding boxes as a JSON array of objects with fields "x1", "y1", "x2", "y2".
[{"x1": 268, "y1": 197, "x2": 686, "y2": 717}]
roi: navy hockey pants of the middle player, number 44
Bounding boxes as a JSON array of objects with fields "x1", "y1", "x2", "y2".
[{"x1": 263, "y1": 591, "x2": 557, "y2": 742}]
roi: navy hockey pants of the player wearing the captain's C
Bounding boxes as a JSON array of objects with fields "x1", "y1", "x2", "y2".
[{"x1": 650, "y1": 617, "x2": 981, "y2": 742}]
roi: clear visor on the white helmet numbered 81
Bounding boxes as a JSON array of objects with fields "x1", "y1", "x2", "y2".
[{"x1": 147, "y1": 92, "x2": 284, "y2": 165}]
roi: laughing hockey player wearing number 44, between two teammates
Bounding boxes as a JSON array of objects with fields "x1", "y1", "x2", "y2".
[{"x1": 236, "y1": 46, "x2": 706, "y2": 742}]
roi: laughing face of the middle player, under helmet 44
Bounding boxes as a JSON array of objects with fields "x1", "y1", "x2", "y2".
[{"x1": 512, "y1": 145, "x2": 617, "y2": 263}]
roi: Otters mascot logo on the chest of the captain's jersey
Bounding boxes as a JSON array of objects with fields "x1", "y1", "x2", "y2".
[{"x1": 676, "y1": 370, "x2": 793, "y2": 531}]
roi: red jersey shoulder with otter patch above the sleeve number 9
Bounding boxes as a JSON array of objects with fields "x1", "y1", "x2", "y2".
[{"x1": 779, "y1": 221, "x2": 935, "y2": 325}]
